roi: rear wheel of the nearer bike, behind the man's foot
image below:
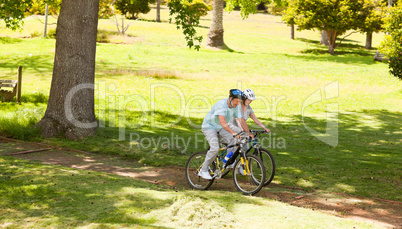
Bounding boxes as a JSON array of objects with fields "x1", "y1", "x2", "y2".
[{"x1": 186, "y1": 152, "x2": 215, "y2": 190}]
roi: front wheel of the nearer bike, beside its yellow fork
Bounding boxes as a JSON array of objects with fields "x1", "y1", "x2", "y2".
[{"x1": 233, "y1": 155, "x2": 265, "y2": 195}]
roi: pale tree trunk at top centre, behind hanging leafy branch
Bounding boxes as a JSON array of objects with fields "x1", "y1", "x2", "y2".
[{"x1": 207, "y1": 0, "x2": 225, "y2": 48}]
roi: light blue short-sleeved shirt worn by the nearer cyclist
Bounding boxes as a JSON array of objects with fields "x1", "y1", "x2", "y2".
[{"x1": 201, "y1": 98, "x2": 242, "y2": 130}]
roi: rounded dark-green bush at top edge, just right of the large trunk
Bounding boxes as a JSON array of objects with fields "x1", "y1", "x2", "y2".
[{"x1": 114, "y1": 0, "x2": 155, "y2": 19}]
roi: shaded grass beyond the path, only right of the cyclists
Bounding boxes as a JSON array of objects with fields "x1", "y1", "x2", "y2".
[{"x1": 256, "y1": 110, "x2": 402, "y2": 201}]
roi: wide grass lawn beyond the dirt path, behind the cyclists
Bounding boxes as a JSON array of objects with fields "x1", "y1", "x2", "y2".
[{"x1": 0, "y1": 4, "x2": 402, "y2": 204}]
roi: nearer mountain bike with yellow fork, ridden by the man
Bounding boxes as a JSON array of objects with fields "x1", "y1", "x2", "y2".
[{"x1": 186, "y1": 132, "x2": 266, "y2": 195}]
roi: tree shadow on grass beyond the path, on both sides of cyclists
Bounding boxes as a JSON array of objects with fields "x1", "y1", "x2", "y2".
[{"x1": 55, "y1": 107, "x2": 402, "y2": 200}]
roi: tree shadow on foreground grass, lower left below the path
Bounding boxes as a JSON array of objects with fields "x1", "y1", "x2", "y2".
[{"x1": 0, "y1": 157, "x2": 172, "y2": 228}]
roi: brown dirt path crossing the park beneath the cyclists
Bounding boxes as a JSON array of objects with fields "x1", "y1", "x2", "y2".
[{"x1": 0, "y1": 138, "x2": 402, "y2": 228}]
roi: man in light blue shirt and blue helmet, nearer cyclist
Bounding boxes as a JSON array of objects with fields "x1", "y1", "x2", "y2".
[{"x1": 198, "y1": 89, "x2": 252, "y2": 180}]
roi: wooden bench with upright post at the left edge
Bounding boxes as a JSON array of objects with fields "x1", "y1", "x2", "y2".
[{"x1": 0, "y1": 66, "x2": 22, "y2": 104}]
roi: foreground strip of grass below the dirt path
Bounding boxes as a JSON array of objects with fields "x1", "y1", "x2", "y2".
[{"x1": 0, "y1": 156, "x2": 382, "y2": 228}]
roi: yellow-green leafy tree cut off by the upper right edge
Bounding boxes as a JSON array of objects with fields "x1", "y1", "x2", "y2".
[{"x1": 380, "y1": 0, "x2": 402, "y2": 79}]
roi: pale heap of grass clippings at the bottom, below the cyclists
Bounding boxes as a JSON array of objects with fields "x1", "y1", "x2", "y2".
[{"x1": 151, "y1": 197, "x2": 239, "y2": 228}]
